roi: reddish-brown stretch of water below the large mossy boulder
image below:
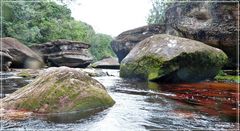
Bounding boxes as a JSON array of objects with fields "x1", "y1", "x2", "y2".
[{"x1": 155, "y1": 82, "x2": 239, "y2": 121}]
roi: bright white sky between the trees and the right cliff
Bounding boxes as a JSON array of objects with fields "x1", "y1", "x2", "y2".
[{"x1": 70, "y1": 0, "x2": 151, "y2": 36}]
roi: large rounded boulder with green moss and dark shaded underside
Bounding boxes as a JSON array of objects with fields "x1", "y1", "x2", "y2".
[{"x1": 120, "y1": 34, "x2": 227, "y2": 82}]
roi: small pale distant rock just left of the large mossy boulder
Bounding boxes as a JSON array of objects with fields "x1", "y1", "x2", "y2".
[{"x1": 90, "y1": 57, "x2": 120, "y2": 69}]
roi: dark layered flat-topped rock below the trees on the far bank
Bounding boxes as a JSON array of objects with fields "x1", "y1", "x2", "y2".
[{"x1": 31, "y1": 40, "x2": 93, "y2": 67}]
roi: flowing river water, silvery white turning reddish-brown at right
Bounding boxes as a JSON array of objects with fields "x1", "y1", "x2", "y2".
[{"x1": 1, "y1": 70, "x2": 238, "y2": 131}]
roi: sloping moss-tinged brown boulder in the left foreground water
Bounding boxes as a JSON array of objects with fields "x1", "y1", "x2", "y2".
[{"x1": 2, "y1": 67, "x2": 115, "y2": 113}]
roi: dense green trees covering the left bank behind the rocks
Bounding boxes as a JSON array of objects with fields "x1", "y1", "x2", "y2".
[{"x1": 1, "y1": 0, "x2": 113, "y2": 60}]
